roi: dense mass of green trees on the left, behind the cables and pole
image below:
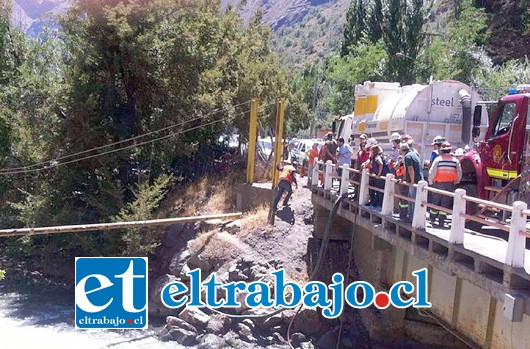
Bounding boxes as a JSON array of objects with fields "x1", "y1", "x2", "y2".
[{"x1": 0, "y1": 0, "x2": 305, "y2": 272}]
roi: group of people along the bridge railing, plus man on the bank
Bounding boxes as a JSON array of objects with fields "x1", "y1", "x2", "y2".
[{"x1": 273, "y1": 132, "x2": 464, "y2": 227}]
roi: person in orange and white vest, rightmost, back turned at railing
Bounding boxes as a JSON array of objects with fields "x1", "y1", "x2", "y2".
[{"x1": 428, "y1": 142, "x2": 462, "y2": 227}]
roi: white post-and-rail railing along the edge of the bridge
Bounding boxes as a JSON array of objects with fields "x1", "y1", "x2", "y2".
[{"x1": 311, "y1": 161, "x2": 530, "y2": 268}]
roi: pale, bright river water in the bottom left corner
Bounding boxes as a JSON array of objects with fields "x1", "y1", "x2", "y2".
[{"x1": 0, "y1": 291, "x2": 179, "y2": 349}]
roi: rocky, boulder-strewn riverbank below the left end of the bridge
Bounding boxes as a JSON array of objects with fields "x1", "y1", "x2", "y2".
[{"x1": 149, "y1": 186, "x2": 370, "y2": 349}]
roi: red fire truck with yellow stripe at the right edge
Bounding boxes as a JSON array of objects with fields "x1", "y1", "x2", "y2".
[{"x1": 460, "y1": 85, "x2": 530, "y2": 204}]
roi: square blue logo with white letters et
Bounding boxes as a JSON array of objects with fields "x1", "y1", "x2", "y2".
[{"x1": 75, "y1": 257, "x2": 147, "y2": 329}]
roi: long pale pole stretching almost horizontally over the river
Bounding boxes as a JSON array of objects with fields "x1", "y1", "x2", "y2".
[{"x1": 0, "y1": 212, "x2": 241, "y2": 237}]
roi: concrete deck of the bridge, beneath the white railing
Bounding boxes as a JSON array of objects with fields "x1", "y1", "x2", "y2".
[{"x1": 311, "y1": 185, "x2": 530, "y2": 298}]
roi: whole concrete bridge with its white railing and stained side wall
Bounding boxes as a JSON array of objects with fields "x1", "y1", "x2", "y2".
[{"x1": 311, "y1": 162, "x2": 530, "y2": 349}]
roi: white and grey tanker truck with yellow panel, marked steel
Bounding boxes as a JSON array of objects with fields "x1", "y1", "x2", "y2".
[{"x1": 338, "y1": 80, "x2": 488, "y2": 164}]
